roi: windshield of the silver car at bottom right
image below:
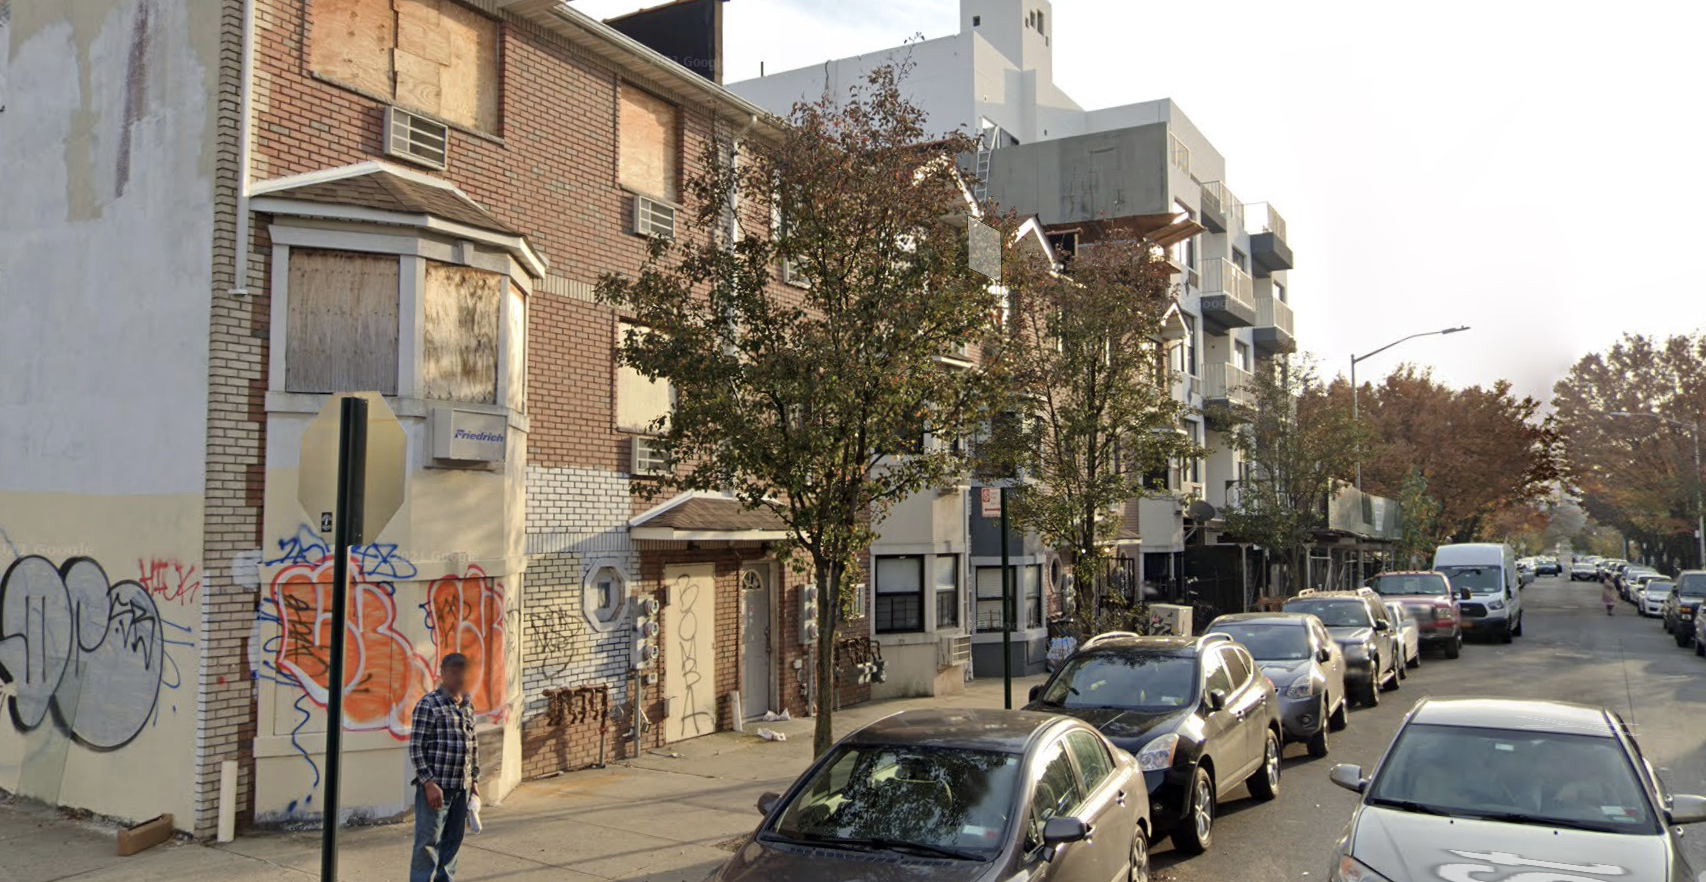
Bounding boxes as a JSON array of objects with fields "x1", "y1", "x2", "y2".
[{"x1": 1368, "y1": 723, "x2": 1655, "y2": 834}]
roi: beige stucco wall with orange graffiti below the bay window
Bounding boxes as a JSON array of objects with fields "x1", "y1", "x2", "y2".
[{"x1": 251, "y1": 396, "x2": 525, "y2": 824}]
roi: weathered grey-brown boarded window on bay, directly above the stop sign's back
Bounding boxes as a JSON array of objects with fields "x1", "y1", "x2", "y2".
[{"x1": 285, "y1": 249, "x2": 397, "y2": 396}]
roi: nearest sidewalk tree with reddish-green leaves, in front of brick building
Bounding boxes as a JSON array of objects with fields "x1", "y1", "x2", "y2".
[{"x1": 597, "y1": 67, "x2": 1010, "y2": 752}]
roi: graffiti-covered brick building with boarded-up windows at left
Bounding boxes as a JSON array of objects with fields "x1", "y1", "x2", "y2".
[{"x1": 0, "y1": 0, "x2": 865, "y2": 836}]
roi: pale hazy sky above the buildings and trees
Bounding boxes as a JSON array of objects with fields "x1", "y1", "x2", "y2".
[{"x1": 575, "y1": 0, "x2": 1706, "y2": 397}]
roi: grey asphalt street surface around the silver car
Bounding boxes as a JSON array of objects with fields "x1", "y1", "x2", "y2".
[{"x1": 1155, "y1": 578, "x2": 1706, "y2": 882}]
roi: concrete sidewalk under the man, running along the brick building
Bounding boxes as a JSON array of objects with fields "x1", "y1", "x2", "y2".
[{"x1": 0, "y1": 677, "x2": 1041, "y2": 882}]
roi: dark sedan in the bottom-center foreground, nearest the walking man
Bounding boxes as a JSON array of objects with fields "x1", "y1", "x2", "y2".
[{"x1": 726, "y1": 710, "x2": 1150, "y2": 882}]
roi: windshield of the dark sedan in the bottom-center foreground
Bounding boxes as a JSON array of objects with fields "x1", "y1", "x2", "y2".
[{"x1": 764, "y1": 744, "x2": 1022, "y2": 856}]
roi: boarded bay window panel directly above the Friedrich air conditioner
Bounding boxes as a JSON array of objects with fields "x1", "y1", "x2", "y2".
[{"x1": 421, "y1": 261, "x2": 503, "y2": 404}]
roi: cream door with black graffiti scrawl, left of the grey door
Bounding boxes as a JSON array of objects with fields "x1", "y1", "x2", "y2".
[{"x1": 662, "y1": 563, "x2": 717, "y2": 740}]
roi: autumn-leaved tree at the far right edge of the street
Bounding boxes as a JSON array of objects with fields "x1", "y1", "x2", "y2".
[{"x1": 1552, "y1": 334, "x2": 1706, "y2": 568}]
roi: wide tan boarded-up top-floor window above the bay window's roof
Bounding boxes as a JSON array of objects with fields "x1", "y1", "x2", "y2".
[{"x1": 312, "y1": 0, "x2": 498, "y2": 131}]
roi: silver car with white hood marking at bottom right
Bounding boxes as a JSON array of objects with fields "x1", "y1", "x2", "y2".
[{"x1": 1327, "y1": 699, "x2": 1706, "y2": 882}]
